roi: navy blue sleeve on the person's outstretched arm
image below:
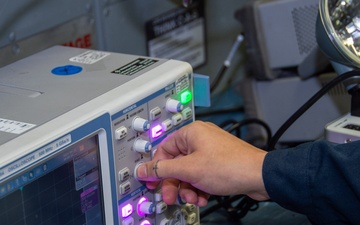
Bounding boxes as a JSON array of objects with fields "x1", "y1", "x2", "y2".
[{"x1": 263, "y1": 141, "x2": 360, "y2": 225}]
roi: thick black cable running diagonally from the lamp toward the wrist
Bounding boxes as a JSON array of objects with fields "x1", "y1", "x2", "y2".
[{"x1": 268, "y1": 70, "x2": 360, "y2": 151}]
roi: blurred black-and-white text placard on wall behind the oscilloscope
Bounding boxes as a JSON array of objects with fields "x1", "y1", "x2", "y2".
[{"x1": 146, "y1": 4, "x2": 206, "y2": 68}]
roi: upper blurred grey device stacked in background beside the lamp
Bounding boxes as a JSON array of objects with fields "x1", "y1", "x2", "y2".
[{"x1": 235, "y1": 0, "x2": 329, "y2": 80}]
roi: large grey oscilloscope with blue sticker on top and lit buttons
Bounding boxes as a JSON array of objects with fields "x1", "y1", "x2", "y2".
[{"x1": 0, "y1": 46, "x2": 200, "y2": 225}]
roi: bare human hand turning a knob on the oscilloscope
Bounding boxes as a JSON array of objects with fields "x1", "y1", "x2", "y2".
[{"x1": 135, "y1": 121, "x2": 269, "y2": 206}]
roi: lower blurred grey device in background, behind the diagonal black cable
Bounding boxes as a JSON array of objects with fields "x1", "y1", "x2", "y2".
[{"x1": 239, "y1": 73, "x2": 350, "y2": 145}]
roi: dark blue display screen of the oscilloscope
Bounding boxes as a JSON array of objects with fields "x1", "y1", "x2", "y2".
[{"x1": 0, "y1": 135, "x2": 104, "y2": 225}]
